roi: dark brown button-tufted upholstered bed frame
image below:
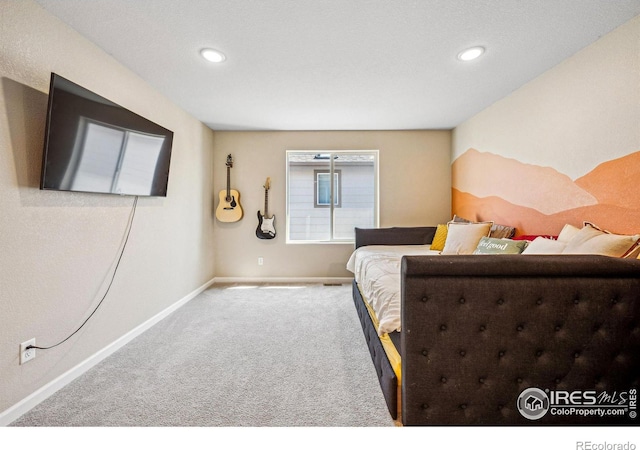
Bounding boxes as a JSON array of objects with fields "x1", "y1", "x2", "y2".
[{"x1": 353, "y1": 227, "x2": 640, "y2": 425}]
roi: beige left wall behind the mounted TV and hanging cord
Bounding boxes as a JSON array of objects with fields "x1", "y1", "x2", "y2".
[{"x1": 0, "y1": 0, "x2": 215, "y2": 413}]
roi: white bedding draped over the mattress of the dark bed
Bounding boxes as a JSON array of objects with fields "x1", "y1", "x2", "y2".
[{"x1": 347, "y1": 244, "x2": 440, "y2": 336}]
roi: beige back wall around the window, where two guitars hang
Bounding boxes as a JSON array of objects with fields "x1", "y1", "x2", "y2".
[{"x1": 211, "y1": 131, "x2": 451, "y2": 279}]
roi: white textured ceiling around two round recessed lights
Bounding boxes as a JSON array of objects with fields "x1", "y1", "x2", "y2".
[{"x1": 37, "y1": 0, "x2": 640, "y2": 130}]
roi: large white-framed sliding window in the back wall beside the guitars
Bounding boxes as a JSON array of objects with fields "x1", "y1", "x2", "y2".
[{"x1": 287, "y1": 150, "x2": 378, "y2": 243}]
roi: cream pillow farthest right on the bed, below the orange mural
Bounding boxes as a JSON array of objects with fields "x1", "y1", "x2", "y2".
[{"x1": 562, "y1": 223, "x2": 640, "y2": 257}]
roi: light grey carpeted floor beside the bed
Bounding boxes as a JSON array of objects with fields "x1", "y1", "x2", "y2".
[{"x1": 11, "y1": 284, "x2": 394, "y2": 427}]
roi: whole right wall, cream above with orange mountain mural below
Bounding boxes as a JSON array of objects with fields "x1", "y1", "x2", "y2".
[{"x1": 451, "y1": 16, "x2": 640, "y2": 235}]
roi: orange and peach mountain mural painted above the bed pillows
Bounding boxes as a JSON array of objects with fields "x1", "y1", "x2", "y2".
[{"x1": 452, "y1": 149, "x2": 640, "y2": 235}]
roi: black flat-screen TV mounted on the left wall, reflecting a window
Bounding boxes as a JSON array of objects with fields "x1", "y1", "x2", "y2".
[{"x1": 40, "y1": 73, "x2": 173, "y2": 197}]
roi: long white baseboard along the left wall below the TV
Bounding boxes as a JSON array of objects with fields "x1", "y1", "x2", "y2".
[{"x1": 0, "y1": 278, "x2": 215, "y2": 427}]
